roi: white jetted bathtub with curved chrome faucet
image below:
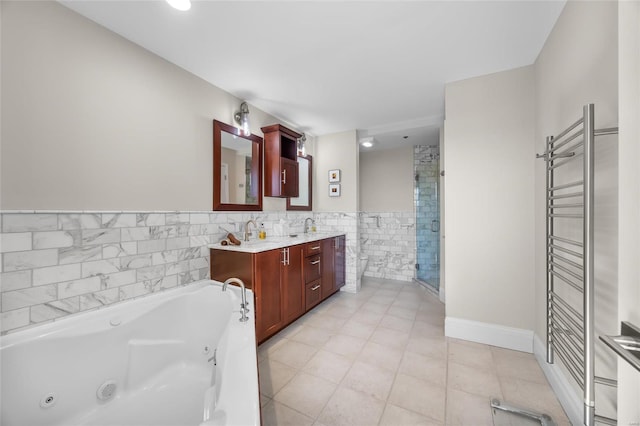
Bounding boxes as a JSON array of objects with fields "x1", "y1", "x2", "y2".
[{"x1": 0, "y1": 281, "x2": 260, "y2": 426}]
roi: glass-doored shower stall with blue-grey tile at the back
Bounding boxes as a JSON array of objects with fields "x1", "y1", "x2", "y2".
[{"x1": 413, "y1": 145, "x2": 440, "y2": 291}]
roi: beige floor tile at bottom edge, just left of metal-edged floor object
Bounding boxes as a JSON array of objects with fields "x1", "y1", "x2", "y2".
[{"x1": 446, "y1": 389, "x2": 493, "y2": 426}]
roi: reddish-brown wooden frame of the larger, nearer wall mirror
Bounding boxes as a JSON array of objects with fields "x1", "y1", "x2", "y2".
[{"x1": 213, "y1": 120, "x2": 263, "y2": 211}]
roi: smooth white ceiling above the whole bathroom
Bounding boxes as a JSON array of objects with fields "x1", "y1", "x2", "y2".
[{"x1": 61, "y1": 0, "x2": 565, "y2": 148}]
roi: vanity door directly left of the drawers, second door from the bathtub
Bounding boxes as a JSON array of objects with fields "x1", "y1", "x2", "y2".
[{"x1": 280, "y1": 245, "x2": 305, "y2": 325}]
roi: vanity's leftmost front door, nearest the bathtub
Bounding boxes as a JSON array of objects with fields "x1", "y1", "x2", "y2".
[{"x1": 254, "y1": 250, "x2": 283, "y2": 342}]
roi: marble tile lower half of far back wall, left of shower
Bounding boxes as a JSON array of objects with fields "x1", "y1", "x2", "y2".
[{"x1": 358, "y1": 211, "x2": 416, "y2": 281}]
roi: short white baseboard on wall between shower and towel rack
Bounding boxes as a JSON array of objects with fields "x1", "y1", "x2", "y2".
[{"x1": 444, "y1": 317, "x2": 533, "y2": 353}]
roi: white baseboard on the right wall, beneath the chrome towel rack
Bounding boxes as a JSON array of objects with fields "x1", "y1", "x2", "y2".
[{"x1": 533, "y1": 335, "x2": 584, "y2": 426}]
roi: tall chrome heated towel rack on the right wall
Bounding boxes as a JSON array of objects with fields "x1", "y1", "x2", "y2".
[{"x1": 537, "y1": 104, "x2": 618, "y2": 426}]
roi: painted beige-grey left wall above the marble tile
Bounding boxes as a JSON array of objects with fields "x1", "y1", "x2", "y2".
[{"x1": 0, "y1": 1, "x2": 285, "y2": 210}]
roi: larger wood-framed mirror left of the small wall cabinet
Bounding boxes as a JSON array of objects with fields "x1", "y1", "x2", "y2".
[{"x1": 213, "y1": 120, "x2": 263, "y2": 211}]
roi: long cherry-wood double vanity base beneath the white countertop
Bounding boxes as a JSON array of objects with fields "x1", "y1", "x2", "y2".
[{"x1": 211, "y1": 235, "x2": 345, "y2": 343}]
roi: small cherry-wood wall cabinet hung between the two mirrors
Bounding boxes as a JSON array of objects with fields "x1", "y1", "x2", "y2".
[{"x1": 262, "y1": 124, "x2": 302, "y2": 198}]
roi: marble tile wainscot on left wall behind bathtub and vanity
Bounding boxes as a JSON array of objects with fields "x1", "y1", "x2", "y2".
[{"x1": 0, "y1": 211, "x2": 358, "y2": 334}]
